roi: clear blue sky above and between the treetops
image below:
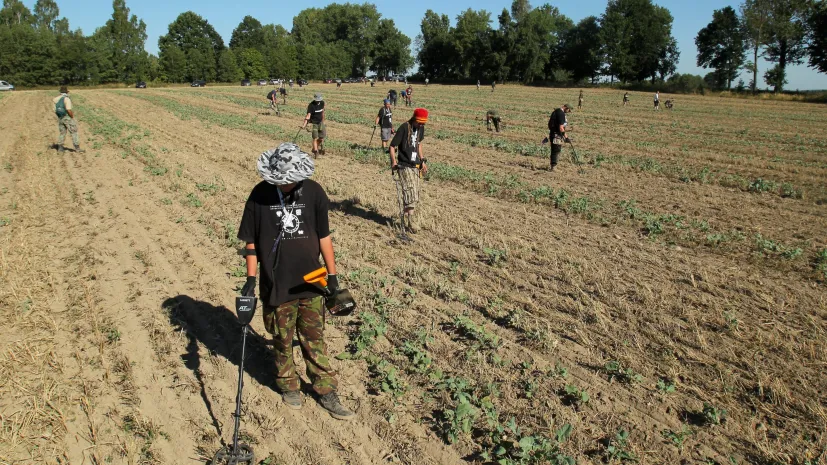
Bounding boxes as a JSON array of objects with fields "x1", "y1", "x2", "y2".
[{"x1": 35, "y1": 0, "x2": 827, "y2": 90}]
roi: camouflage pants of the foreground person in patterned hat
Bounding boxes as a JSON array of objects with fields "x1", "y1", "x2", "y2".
[{"x1": 263, "y1": 296, "x2": 337, "y2": 395}]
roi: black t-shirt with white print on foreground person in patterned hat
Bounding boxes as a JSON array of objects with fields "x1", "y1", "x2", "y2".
[{"x1": 238, "y1": 179, "x2": 330, "y2": 306}]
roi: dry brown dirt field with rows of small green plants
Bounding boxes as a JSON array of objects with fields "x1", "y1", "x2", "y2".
[{"x1": 0, "y1": 84, "x2": 827, "y2": 465}]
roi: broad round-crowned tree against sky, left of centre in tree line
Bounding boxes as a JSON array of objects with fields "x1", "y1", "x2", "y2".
[{"x1": 158, "y1": 11, "x2": 224, "y2": 80}]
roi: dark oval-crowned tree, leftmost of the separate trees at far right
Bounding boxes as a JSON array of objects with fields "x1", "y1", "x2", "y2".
[{"x1": 695, "y1": 6, "x2": 746, "y2": 89}]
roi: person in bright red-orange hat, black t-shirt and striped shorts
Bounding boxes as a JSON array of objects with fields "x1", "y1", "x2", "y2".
[{"x1": 389, "y1": 108, "x2": 428, "y2": 234}]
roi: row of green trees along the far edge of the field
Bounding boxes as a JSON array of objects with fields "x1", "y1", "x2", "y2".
[{"x1": 0, "y1": 0, "x2": 827, "y2": 91}]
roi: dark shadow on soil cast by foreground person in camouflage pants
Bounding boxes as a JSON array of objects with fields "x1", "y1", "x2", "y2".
[{"x1": 162, "y1": 295, "x2": 275, "y2": 443}]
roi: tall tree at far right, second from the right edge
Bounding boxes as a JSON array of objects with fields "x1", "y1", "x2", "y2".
[{"x1": 765, "y1": 0, "x2": 810, "y2": 92}]
